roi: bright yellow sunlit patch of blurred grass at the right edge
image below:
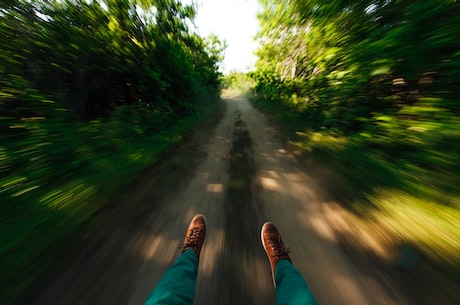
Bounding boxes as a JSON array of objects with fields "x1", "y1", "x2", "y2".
[{"x1": 366, "y1": 189, "x2": 460, "y2": 269}]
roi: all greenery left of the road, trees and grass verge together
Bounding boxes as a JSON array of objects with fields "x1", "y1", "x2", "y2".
[{"x1": 0, "y1": 0, "x2": 223, "y2": 304}]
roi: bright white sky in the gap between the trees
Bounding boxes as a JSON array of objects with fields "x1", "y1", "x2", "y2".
[{"x1": 190, "y1": 0, "x2": 259, "y2": 73}]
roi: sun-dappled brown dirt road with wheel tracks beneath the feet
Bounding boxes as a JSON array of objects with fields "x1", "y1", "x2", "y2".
[{"x1": 28, "y1": 99, "x2": 398, "y2": 305}]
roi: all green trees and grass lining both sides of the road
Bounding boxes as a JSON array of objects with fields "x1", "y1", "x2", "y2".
[{"x1": 0, "y1": 0, "x2": 460, "y2": 304}]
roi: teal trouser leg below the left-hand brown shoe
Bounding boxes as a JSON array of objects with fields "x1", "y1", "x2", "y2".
[{"x1": 144, "y1": 249, "x2": 198, "y2": 305}]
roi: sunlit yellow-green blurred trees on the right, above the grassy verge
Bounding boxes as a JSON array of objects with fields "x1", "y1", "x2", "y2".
[{"x1": 255, "y1": 0, "x2": 460, "y2": 131}]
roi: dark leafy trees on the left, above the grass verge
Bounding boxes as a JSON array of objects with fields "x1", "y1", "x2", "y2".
[{"x1": 0, "y1": 0, "x2": 221, "y2": 120}]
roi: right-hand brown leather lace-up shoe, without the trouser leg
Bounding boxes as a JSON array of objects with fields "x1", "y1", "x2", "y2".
[{"x1": 260, "y1": 222, "x2": 292, "y2": 287}]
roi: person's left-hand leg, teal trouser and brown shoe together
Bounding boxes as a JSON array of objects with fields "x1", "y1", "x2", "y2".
[{"x1": 145, "y1": 214, "x2": 206, "y2": 305}]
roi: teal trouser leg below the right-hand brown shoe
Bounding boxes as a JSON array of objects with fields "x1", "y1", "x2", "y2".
[{"x1": 275, "y1": 259, "x2": 318, "y2": 305}]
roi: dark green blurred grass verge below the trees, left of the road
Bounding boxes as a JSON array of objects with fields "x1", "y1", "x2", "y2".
[{"x1": 0, "y1": 98, "x2": 219, "y2": 304}]
